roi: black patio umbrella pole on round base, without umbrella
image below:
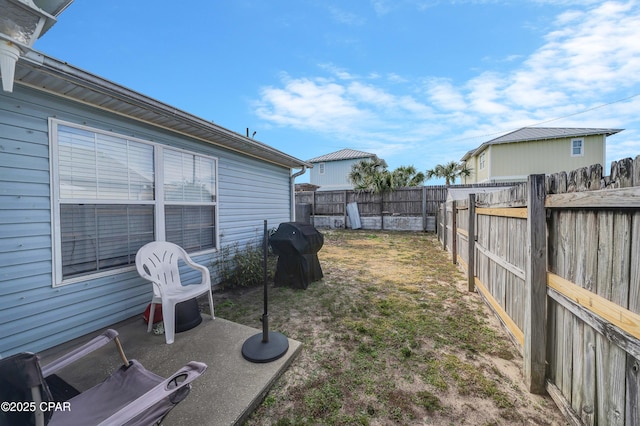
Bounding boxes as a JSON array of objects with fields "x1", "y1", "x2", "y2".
[{"x1": 242, "y1": 220, "x2": 289, "y2": 362}]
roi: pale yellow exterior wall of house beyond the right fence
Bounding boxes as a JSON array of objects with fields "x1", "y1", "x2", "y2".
[{"x1": 464, "y1": 135, "x2": 606, "y2": 183}]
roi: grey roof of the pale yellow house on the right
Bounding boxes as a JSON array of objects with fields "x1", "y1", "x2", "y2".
[{"x1": 461, "y1": 127, "x2": 623, "y2": 161}]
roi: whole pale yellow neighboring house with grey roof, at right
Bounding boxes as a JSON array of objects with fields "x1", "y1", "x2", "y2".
[{"x1": 460, "y1": 127, "x2": 622, "y2": 184}]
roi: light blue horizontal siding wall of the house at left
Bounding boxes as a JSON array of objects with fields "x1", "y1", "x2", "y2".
[{"x1": 0, "y1": 84, "x2": 292, "y2": 357}]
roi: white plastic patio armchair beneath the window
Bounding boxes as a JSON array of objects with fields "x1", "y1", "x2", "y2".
[{"x1": 136, "y1": 241, "x2": 215, "y2": 344}]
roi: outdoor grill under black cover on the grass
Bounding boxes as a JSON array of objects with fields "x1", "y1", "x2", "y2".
[{"x1": 269, "y1": 222, "x2": 324, "y2": 289}]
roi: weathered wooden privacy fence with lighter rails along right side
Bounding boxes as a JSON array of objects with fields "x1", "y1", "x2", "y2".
[{"x1": 437, "y1": 156, "x2": 640, "y2": 425}]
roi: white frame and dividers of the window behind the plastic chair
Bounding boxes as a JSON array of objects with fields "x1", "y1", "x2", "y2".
[{"x1": 49, "y1": 118, "x2": 220, "y2": 287}]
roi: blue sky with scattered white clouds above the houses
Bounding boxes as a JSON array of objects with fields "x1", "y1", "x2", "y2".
[{"x1": 34, "y1": 0, "x2": 640, "y2": 183}]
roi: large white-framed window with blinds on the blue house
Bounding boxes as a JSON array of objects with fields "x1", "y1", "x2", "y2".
[{"x1": 51, "y1": 120, "x2": 217, "y2": 285}]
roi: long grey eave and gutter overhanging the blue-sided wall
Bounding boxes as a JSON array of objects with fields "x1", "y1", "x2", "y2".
[{"x1": 15, "y1": 51, "x2": 313, "y2": 168}]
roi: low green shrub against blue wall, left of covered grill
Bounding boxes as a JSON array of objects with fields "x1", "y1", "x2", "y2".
[{"x1": 213, "y1": 241, "x2": 277, "y2": 289}]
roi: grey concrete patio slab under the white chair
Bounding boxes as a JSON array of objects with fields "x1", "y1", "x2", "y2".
[{"x1": 40, "y1": 314, "x2": 302, "y2": 426}]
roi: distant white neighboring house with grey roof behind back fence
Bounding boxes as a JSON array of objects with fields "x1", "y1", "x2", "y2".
[{"x1": 307, "y1": 149, "x2": 377, "y2": 191}]
